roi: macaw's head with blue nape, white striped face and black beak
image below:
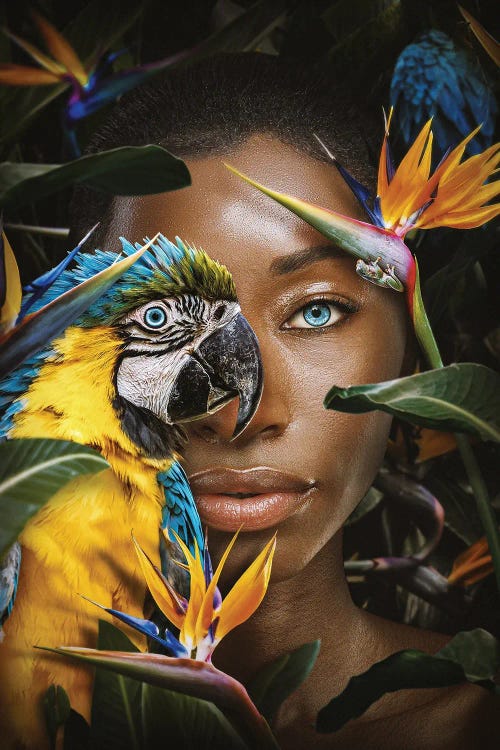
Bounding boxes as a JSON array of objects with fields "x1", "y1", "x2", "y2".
[{"x1": 0, "y1": 235, "x2": 263, "y2": 456}]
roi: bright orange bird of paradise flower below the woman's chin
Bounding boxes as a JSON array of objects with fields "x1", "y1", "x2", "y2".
[{"x1": 43, "y1": 529, "x2": 279, "y2": 750}]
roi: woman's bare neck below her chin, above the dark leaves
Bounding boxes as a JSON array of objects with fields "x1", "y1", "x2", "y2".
[{"x1": 210, "y1": 531, "x2": 366, "y2": 697}]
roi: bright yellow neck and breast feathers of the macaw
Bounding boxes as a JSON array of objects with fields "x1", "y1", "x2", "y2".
[{"x1": 0, "y1": 327, "x2": 171, "y2": 750}]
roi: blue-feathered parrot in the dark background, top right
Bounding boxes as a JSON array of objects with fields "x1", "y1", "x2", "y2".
[{"x1": 390, "y1": 29, "x2": 498, "y2": 155}]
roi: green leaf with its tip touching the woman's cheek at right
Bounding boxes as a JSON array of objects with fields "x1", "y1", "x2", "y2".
[{"x1": 324, "y1": 363, "x2": 500, "y2": 441}]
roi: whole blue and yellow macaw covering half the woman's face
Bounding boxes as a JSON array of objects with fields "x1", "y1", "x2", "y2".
[{"x1": 0, "y1": 235, "x2": 262, "y2": 750}]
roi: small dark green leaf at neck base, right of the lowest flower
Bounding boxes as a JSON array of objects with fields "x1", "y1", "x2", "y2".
[{"x1": 248, "y1": 640, "x2": 320, "y2": 723}]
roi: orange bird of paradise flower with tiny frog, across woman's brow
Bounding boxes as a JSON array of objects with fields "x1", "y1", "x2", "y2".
[{"x1": 226, "y1": 109, "x2": 500, "y2": 366}]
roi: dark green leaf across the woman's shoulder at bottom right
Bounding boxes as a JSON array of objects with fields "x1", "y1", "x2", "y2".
[{"x1": 316, "y1": 628, "x2": 500, "y2": 733}]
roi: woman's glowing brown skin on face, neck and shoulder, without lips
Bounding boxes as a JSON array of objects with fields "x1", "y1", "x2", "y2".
[{"x1": 110, "y1": 135, "x2": 498, "y2": 750}]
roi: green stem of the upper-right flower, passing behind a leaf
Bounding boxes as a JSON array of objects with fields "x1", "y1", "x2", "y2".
[{"x1": 413, "y1": 266, "x2": 500, "y2": 592}]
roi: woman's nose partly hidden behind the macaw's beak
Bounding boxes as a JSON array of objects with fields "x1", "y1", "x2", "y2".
[{"x1": 191, "y1": 353, "x2": 292, "y2": 445}]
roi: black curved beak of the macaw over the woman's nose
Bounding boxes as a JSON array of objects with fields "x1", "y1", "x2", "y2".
[{"x1": 168, "y1": 313, "x2": 264, "y2": 440}]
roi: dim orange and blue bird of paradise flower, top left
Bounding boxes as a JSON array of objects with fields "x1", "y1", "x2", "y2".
[{"x1": 0, "y1": 11, "x2": 189, "y2": 156}]
